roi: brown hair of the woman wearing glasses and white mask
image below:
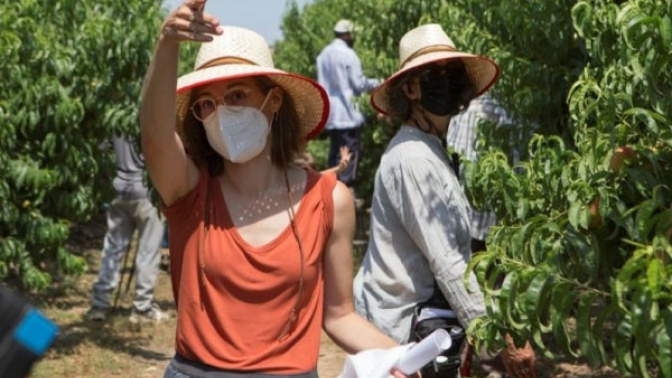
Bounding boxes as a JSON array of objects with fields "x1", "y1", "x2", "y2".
[{"x1": 183, "y1": 76, "x2": 306, "y2": 176}]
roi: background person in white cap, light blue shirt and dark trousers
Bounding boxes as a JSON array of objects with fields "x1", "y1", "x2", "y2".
[{"x1": 317, "y1": 20, "x2": 380, "y2": 190}]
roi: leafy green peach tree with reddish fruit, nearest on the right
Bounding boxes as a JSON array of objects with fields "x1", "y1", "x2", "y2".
[{"x1": 468, "y1": 1, "x2": 672, "y2": 377}]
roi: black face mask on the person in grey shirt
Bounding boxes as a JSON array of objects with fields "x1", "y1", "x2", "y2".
[{"x1": 420, "y1": 70, "x2": 457, "y2": 116}]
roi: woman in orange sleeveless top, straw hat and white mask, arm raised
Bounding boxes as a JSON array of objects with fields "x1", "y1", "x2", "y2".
[{"x1": 140, "y1": 0, "x2": 414, "y2": 377}]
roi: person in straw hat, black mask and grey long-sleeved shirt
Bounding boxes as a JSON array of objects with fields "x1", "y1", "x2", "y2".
[{"x1": 354, "y1": 24, "x2": 532, "y2": 377}]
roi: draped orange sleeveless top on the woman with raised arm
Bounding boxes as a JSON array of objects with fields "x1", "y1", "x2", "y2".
[{"x1": 163, "y1": 167, "x2": 336, "y2": 374}]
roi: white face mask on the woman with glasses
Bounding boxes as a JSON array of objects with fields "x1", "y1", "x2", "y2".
[{"x1": 203, "y1": 92, "x2": 271, "y2": 163}]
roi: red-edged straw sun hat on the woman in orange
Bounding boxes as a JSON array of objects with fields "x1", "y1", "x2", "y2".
[{"x1": 176, "y1": 26, "x2": 329, "y2": 140}]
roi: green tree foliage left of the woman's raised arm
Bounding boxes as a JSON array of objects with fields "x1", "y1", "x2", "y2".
[{"x1": 0, "y1": 0, "x2": 165, "y2": 289}]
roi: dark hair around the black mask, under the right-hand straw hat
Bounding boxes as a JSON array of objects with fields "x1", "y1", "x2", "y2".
[{"x1": 385, "y1": 59, "x2": 476, "y2": 122}]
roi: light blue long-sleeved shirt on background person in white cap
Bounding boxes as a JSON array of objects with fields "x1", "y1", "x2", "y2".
[{"x1": 317, "y1": 38, "x2": 380, "y2": 130}]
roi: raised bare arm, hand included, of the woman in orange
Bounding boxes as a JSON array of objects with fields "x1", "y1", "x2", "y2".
[{"x1": 140, "y1": 0, "x2": 222, "y2": 205}]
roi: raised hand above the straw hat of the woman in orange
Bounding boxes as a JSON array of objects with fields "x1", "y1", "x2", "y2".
[{"x1": 161, "y1": 0, "x2": 222, "y2": 43}]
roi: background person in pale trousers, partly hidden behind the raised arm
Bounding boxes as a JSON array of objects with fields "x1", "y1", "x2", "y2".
[{"x1": 86, "y1": 134, "x2": 167, "y2": 322}]
